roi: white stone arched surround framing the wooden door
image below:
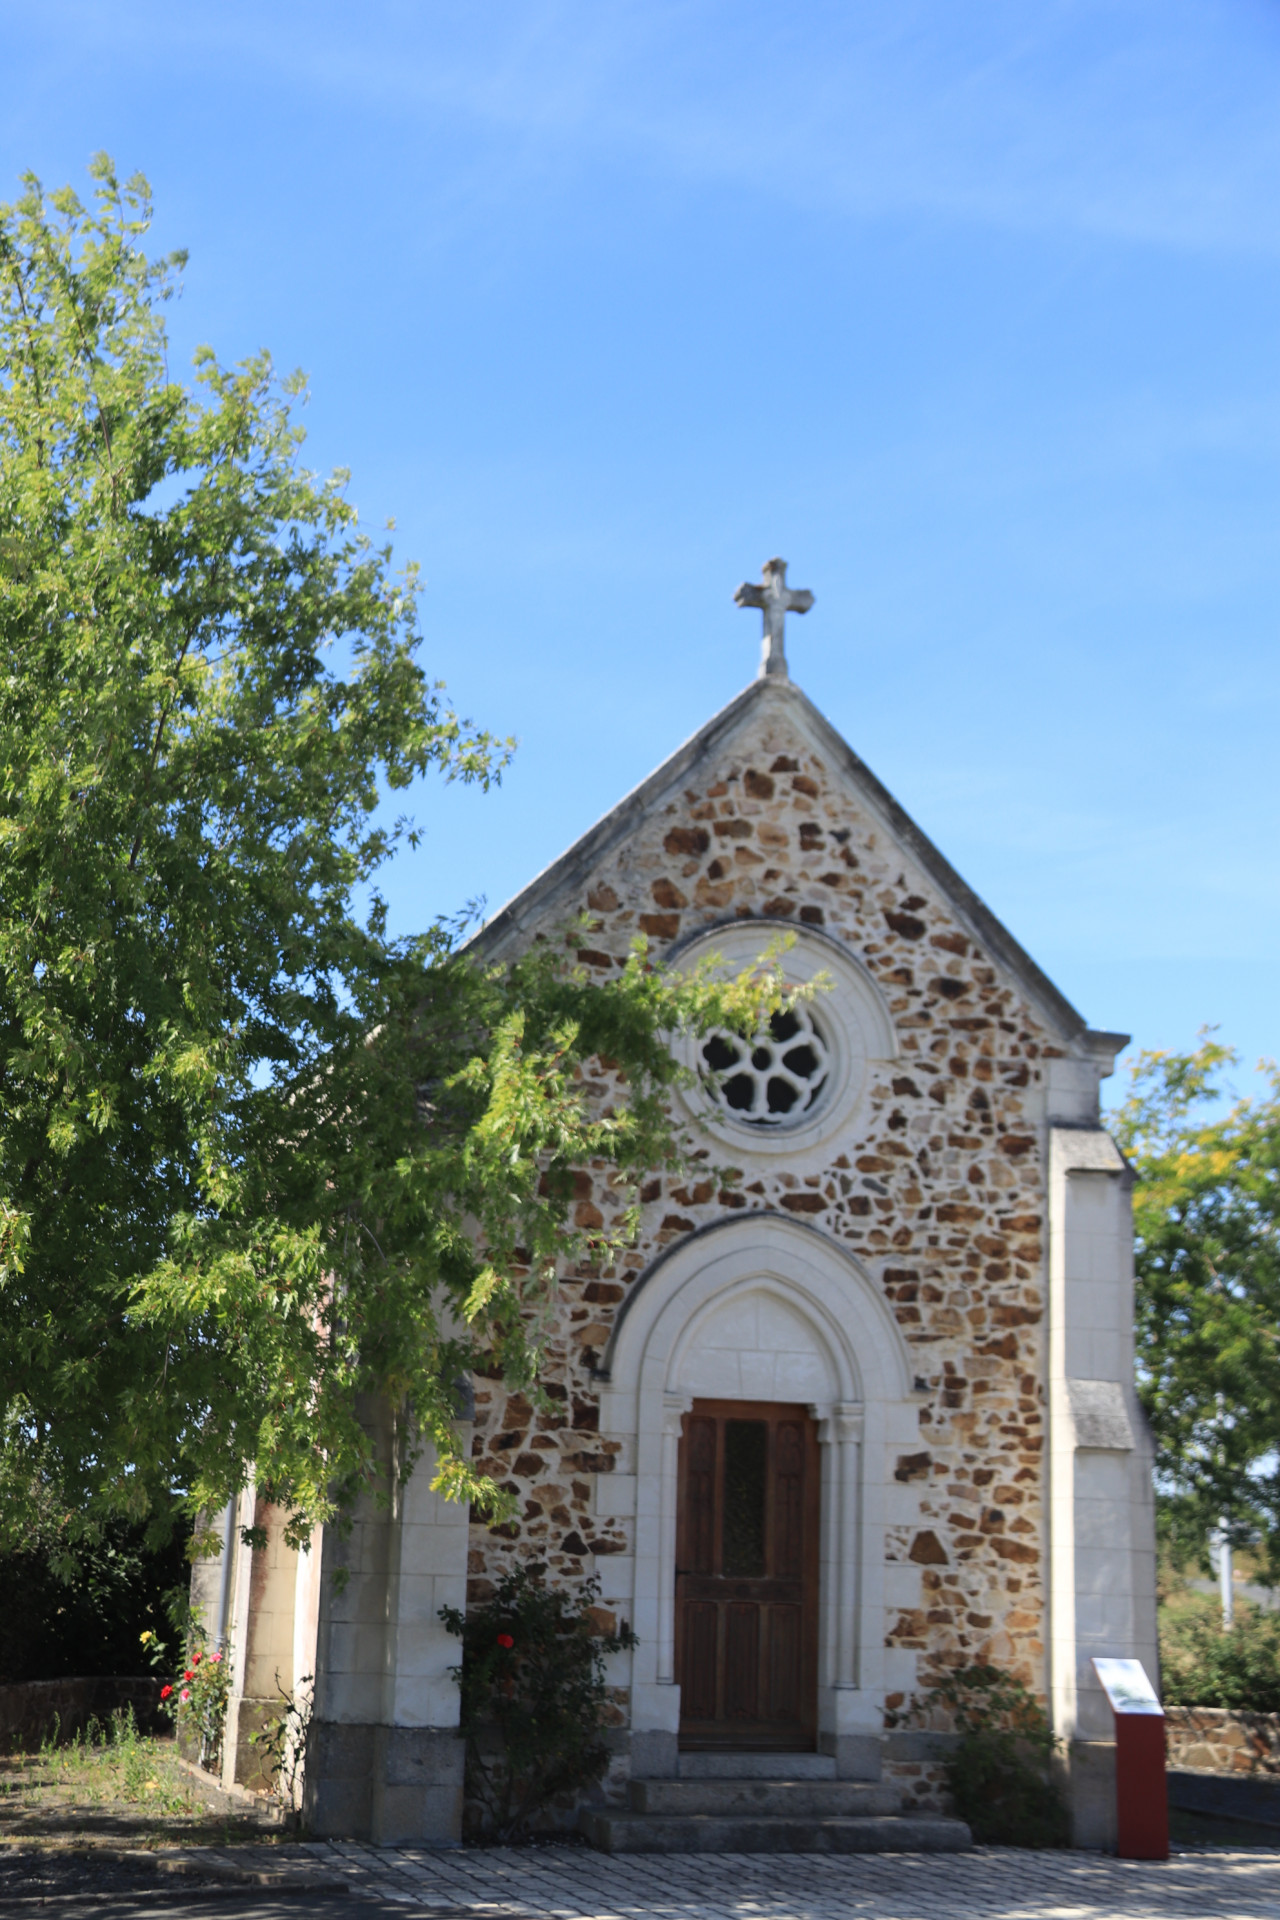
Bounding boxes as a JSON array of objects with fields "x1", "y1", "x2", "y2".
[{"x1": 601, "y1": 1213, "x2": 919, "y2": 1736}]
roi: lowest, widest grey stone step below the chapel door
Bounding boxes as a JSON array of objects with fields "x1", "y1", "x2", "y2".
[{"x1": 580, "y1": 1809, "x2": 973, "y2": 1853}]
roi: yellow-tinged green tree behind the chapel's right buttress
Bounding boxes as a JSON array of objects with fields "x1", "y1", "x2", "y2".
[{"x1": 1115, "y1": 1033, "x2": 1280, "y2": 1578}]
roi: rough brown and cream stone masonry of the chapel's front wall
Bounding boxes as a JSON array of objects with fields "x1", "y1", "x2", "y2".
[{"x1": 470, "y1": 710, "x2": 1055, "y2": 1758}]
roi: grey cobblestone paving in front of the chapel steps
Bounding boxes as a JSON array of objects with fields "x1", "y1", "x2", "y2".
[{"x1": 295, "y1": 1841, "x2": 1280, "y2": 1920}]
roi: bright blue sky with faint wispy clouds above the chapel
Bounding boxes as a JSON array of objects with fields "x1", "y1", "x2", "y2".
[{"x1": 0, "y1": 0, "x2": 1280, "y2": 1113}]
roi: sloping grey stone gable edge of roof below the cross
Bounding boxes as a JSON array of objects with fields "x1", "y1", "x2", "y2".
[{"x1": 466, "y1": 678, "x2": 1128, "y2": 1054}]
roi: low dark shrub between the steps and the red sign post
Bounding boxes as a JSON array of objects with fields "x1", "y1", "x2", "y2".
[{"x1": 927, "y1": 1667, "x2": 1071, "y2": 1847}]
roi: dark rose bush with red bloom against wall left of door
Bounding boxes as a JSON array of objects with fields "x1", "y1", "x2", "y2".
[{"x1": 439, "y1": 1567, "x2": 635, "y2": 1843}]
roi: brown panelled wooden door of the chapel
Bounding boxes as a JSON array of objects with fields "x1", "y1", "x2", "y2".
[{"x1": 676, "y1": 1400, "x2": 819, "y2": 1749}]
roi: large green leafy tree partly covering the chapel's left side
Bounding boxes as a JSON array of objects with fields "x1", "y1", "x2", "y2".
[{"x1": 0, "y1": 156, "x2": 779, "y2": 1540}]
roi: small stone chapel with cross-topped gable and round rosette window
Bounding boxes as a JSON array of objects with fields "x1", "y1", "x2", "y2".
[{"x1": 194, "y1": 561, "x2": 1157, "y2": 1847}]
